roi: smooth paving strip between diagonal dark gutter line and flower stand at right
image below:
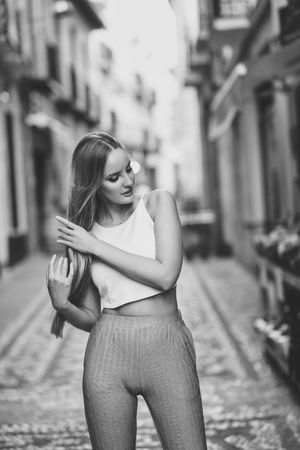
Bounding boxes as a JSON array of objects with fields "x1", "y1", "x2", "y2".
[{"x1": 193, "y1": 258, "x2": 271, "y2": 379}]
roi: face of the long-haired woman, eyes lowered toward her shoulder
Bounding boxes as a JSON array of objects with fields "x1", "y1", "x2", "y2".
[{"x1": 101, "y1": 148, "x2": 135, "y2": 204}]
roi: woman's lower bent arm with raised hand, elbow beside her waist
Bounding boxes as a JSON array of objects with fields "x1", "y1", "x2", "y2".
[{"x1": 47, "y1": 255, "x2": 100, "y2": 332}]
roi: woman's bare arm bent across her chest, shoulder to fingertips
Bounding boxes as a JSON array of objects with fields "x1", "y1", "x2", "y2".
[{"x1": 59, "y1": 190, "x2": 182, "y2": 290}]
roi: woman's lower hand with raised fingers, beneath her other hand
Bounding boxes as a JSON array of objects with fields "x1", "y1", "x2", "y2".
[{"x1": 46, "y1": 255, "x2": 74, "y2": 311}]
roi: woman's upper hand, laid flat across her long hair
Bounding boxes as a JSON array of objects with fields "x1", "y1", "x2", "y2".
[{"x1": 56, "y1": 216, "x2": 96, "y2": 253}]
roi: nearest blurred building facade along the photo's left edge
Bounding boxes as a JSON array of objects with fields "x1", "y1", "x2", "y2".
[{"x1": 0, "y1": 0, "x2": 33, "y2": 267}]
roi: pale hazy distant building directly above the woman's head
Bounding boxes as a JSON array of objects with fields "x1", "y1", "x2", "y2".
[{"x1": 90, "y1": 29, "x2": 158, "y2": 187}]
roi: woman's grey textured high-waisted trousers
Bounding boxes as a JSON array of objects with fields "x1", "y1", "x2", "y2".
[{"x1": 83, "y1": 310, "x2": 206, "y2": 450}]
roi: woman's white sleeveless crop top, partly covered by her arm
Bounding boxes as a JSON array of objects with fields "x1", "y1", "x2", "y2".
[{"x1": 91, "y1": 196, "x2": 162, "y2": 308}]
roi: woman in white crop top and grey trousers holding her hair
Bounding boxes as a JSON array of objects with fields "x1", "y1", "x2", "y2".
[{"x1": 47, "y1": 132, "x2": 206, "y2": 450}]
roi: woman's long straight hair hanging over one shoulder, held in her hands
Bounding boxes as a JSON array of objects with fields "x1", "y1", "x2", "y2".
[{"x1": 51, "y1": 132, "x2": 125, "y2": 337}]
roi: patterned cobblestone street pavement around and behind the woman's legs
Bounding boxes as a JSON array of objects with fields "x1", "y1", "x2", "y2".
[{"x1": 0, "y1": 255, "x2": 300, "y2": 450}]
